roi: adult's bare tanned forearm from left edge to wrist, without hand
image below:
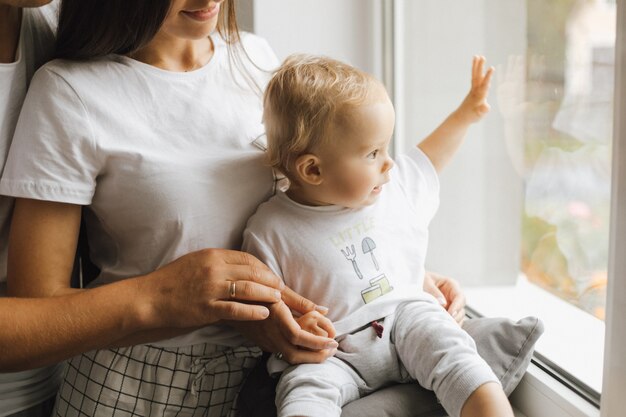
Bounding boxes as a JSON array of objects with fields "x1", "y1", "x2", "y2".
[{"x1": 0, "y1": 280, "x2": 159, "y2": 372}]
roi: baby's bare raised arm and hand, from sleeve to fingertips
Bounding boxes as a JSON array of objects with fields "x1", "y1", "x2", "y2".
[{"x1": 418, "y1": 56, "x2": 494, "y2": 172}]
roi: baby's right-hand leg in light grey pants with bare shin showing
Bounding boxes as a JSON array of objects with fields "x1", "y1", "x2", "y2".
[{"x1": 391, "y1": 296, "x2": 513, "y2": 417}]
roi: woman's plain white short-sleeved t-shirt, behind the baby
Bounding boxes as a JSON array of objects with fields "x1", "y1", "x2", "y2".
[{"x1": 0, "y1": 34, "x2": 278, "y2": 346}]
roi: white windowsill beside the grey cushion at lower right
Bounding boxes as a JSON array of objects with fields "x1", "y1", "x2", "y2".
[{"x1": 465, "y1": 277, "x2": 604, "y2": 417}]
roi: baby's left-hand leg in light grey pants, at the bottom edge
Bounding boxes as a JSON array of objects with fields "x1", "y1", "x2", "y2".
[{"x1": 276, "y1": 358, "x2": 362, "y2": 417}]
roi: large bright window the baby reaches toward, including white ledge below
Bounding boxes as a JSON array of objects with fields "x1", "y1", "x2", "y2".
[{"x1": 393, "y1": 0, "x2": 623, "y2": 410}]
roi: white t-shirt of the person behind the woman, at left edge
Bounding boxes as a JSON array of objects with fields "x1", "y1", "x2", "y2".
[{"x1": 0, "y1": 1, "x2": 62, "y2": 417}]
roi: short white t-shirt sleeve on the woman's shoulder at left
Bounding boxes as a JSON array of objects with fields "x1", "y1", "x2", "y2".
[{"x1": 0, "y1": 66, "x2": 103, "y2": 205}]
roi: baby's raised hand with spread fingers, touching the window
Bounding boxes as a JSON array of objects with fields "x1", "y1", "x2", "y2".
[{"x1": 457, "y1": 56, "x2": 495, "y2": 123}]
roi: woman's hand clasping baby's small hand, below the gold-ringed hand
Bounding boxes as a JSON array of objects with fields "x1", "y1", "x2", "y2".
[{"x1": 230, "y1": 287, "x2": 338, "y2": 364}]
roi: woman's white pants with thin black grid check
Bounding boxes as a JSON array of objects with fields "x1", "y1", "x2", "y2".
[{"x1": 52, "y1": 344, "x2": 261, "y2": 417}]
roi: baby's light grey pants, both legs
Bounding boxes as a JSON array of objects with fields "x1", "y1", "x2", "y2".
[{"x1": 276, "y1": 298, "x2": 499, "y2": 417}]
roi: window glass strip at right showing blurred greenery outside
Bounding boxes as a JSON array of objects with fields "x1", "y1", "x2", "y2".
[{"x1": 520, "y1": 0, "x2": 615, "y2": 319}]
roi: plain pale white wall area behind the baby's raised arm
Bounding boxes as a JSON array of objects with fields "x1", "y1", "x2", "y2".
[{"x1": 403, "y1": 0, "x2": 526, "y2": 285}]
